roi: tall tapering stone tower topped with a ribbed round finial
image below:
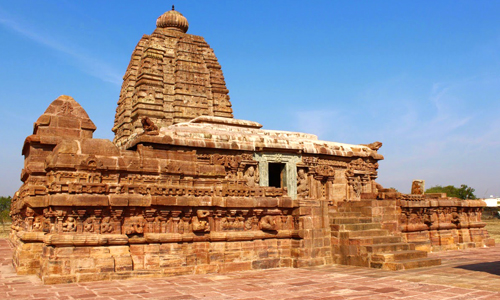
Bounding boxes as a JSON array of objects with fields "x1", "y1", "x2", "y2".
[{"x1": 113, "y1": 10, "x2": 233, "y2": 145}]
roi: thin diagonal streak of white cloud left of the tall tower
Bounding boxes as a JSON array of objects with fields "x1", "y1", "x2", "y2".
[{"x1": 0, "y1": 10, "x2": 122, "y2": 86}]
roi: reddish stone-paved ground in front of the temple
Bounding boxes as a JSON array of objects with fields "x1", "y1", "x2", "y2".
[{"x1": 0, "y1": 239, "x2": 500, "y2": 300}]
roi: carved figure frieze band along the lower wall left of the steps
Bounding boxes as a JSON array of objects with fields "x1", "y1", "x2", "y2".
[{"x1": 21, "y1": 207, "x2": 298, "y2": 236}]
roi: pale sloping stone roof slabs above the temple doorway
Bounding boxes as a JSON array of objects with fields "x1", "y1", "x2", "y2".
[{"x1": 124, "y1": 116, "x2": 384, "y2": 160}]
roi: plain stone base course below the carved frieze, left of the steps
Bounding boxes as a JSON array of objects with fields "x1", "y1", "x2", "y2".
[{"x1": 14, "y1": 237, "x2": 293, "y2": 284}]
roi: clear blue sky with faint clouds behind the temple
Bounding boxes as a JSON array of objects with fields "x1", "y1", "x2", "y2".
[{"x1": 0, "y1": 0, "x2": 500, "y2": 197}]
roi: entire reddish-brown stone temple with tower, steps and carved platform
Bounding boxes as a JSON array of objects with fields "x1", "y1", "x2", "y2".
[{"x1": 10, "y1": 10, "x2": 494, "y2": 284}]
